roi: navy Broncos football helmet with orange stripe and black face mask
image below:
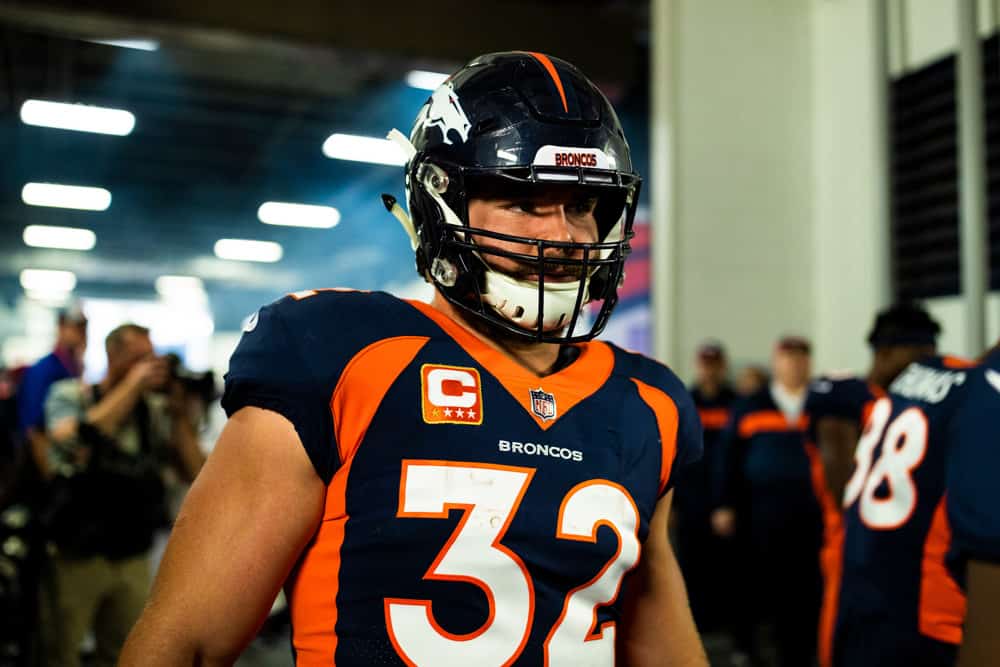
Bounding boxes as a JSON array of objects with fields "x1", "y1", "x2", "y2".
[{"x1": 383, "y1": 52, "x2": 641, "y2": 343}]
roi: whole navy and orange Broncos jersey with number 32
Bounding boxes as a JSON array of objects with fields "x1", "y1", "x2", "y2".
[{"x1": 223, "y1": 291, "x2": 701, "y2": 667}]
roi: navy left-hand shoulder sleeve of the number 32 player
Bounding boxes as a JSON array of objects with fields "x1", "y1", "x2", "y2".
[{"x1": 222, "y1": 298, "x2": 339, "y2": 482}]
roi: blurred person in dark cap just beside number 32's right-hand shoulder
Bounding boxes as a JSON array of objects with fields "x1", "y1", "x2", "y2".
[{"x1": 674, "y1": 340, "x2": 736, "y2": 633}]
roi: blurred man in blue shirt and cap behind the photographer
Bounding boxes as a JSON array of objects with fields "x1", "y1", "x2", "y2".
[{"x1": 17, "y1": 304, "x2": 87, "y2": 486}]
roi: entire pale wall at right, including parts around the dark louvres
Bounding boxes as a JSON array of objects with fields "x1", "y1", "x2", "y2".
[{"x1": 650, "y1": 0, "x2": 1000, "y2": 376}]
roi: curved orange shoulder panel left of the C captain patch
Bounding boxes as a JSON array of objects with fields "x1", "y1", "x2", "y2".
[{"x1": 330, "y1": 336, "x2": 430, "y2": 464}]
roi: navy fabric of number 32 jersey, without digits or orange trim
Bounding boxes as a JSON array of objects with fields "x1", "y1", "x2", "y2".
[{"x1": 224, "y1": 292, "x2": 701, "y2": 666}]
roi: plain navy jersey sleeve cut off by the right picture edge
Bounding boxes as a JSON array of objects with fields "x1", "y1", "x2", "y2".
[{"x1": 947, "y1": 369, "x2": 1000, "y2": 567}]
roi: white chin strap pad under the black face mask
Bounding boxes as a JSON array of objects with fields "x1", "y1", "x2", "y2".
[{"x1": 483, "y1": 269, "x2": 589, "y2": 331}]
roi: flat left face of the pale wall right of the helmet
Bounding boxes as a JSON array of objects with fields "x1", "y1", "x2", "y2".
[{"x1": 651, "y1": 0, "x2": 814, "y2": 377}]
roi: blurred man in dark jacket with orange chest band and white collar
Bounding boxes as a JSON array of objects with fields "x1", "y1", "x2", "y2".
[{"x1": 712, "y1": 336, "x2": 822, "y2": 667}]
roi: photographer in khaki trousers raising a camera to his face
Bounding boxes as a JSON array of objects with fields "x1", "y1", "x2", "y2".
[{"x1": 44, "y1": 324, "x2": 204, "y2": 665}]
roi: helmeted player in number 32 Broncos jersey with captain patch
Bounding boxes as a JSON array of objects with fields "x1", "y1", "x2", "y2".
[{"x1": 122, "y1": 52, "x2": 707, "y2": 667}]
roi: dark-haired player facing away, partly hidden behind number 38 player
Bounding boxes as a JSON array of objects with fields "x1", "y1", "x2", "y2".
[{"x1": 806, "y1": 303, "x2": 941, "y2": 667}]
